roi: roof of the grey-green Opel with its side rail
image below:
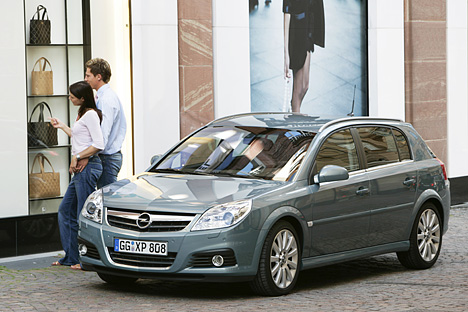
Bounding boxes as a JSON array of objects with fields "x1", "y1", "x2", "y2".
[{"x1": 208, "y1": 112, "x2": 403, "y2": 133}]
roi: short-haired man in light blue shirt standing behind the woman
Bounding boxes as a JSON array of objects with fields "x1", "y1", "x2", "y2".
[{"x1": 79, "y1": 58, "x2": 127, "y2": 188}]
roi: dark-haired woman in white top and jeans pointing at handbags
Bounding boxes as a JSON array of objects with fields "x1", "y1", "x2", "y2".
[{"x1": 50, "y1": 81, "x2": 104, "y2": 270}]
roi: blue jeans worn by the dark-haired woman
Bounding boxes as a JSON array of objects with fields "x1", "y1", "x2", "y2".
[{"x1": 58, "y1": 156, "x2": 102, "y2": 265}]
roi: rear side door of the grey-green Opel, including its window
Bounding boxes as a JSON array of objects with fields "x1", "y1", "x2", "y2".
[{"x1": 356, "y1": 126, "x2": 417, "y2": 246}]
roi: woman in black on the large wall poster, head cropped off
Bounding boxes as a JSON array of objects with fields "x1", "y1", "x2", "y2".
[{"x1": 283, "y1": 0, "x2": 325, "y2": 112}]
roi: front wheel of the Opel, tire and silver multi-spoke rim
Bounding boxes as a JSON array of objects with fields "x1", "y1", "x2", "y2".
[{"x1": 250, "y1": 221, "x2": 301, "y2": 296}]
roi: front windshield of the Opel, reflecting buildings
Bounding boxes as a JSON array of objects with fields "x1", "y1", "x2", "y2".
[{"x1": 150, "y1": 126, "x2": 315, "y2": 181}]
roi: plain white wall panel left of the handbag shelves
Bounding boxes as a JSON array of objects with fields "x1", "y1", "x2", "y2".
[{"x1": 0, "y1": 1, "x2": 29, "y2": 218}]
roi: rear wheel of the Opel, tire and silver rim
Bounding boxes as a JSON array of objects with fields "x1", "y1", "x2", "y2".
[{"x1": 397, "y1": 203, "x2": 442, "y2": 270}]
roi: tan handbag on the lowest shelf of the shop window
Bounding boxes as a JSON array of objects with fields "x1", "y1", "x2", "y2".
[{"x1": 29, "y1": 153, "x2": 60, "y2": 198}]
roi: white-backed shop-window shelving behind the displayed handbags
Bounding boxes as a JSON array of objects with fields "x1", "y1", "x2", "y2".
[{"x1": 23, "y1": 0, "x2": 91, "y2": 215}]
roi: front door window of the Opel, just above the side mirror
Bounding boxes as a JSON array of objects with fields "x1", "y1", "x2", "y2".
[{"x1": 315, "y1": 129, "x2": 359, "y2": 172}]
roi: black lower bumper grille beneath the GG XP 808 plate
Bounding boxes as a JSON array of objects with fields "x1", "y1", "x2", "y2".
[{"x1": 108, "y1": 247, "x2": 177, "y2": 268}]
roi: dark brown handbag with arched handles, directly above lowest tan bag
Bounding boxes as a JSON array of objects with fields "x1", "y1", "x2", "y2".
[{"x1": 28, "y1": 102, "x2": 58, "y2": 147}]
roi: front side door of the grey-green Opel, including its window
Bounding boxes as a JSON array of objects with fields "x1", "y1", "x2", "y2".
[{"x1": 310, "y1": 129, "x2": 370, "y2": 256}]
